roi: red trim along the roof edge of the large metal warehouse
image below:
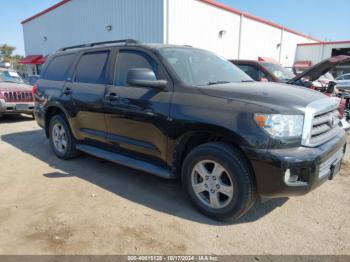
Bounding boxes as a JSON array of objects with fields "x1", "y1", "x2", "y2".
[{"x1": 22, "y1": 0, "x2": 321, "y2": 42}]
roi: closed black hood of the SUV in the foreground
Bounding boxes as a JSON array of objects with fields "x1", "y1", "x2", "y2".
[{"x1": 198, "y1": 82, "x2": 326, "y2": 113}]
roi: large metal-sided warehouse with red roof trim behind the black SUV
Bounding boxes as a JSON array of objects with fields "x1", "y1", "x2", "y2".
[{"x1": 22, "y1": 0, "x2": 318, "y2": 74}]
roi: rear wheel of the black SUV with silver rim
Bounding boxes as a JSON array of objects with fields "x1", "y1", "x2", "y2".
[{"x1": 49, "y1": 114, "x2": 78, "y2": 160}]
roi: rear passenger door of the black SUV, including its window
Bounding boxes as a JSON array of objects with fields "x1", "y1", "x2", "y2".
[{"x1": 64, "y1": 49, "x2": 113, "y2": 142}]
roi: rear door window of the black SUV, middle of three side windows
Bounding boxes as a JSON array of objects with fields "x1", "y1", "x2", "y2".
[{"x1": 75, "y1": 51, "x2": 109, "y2": 84}]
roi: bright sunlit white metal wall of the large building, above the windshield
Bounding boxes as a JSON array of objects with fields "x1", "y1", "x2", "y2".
[{"x1": 165, "y1": 0, "x2": 315, "y2": 66}]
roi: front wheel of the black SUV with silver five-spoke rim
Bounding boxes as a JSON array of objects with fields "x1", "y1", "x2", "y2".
[{"x1": 182, "y1": 142, "x2": 256, "y2": 221}]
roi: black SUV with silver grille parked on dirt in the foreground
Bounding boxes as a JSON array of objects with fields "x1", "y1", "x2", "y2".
[{"x1": 34, "y1": 40, "x2": 346, "y2": 220}]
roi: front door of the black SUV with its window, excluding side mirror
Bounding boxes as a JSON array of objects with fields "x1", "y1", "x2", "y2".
[{"x1": 105, "y1": 50, "x2": 171, "y2": 165}]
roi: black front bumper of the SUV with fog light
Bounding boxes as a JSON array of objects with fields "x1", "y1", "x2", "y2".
[{"x1": 244, "y1": 128, "x2": 346, "y2": 198}]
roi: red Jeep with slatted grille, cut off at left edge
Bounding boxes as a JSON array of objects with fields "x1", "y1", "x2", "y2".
[{"x1": 0, "y1": 68, "x2": 34, "y2": 117}]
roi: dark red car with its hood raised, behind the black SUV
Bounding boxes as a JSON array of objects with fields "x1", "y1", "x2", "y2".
[{"x1": 231, "y1": 56, "x2": 350, "y2": 130}]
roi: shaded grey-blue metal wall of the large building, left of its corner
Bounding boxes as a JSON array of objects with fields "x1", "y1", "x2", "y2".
[{"x1": 23, "y1": 0, "x2": 163, "y2": 55}]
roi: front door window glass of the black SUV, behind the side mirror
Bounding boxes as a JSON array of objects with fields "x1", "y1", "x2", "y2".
[{"x1": 115, "y1": 52, "x2": 153, "y2": 86}]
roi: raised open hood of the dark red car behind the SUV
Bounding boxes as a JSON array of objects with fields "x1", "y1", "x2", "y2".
[{"x1": 287, "y1": 55, "x2": 350, "y2": 84}]
